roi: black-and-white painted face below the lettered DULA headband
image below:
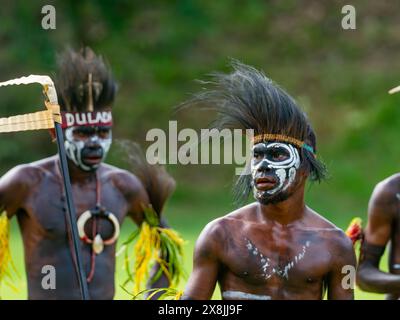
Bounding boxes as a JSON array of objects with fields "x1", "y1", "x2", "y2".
[{"x1": 64, "y1": 126, "x2": 112, "y2": 171}]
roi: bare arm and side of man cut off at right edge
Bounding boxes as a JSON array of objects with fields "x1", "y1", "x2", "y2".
[{"x1": 357, "y1": 174, "x2": 400, "y2": 299}]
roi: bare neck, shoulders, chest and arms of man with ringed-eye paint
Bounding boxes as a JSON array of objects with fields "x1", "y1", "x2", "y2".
[{"x1": 183, "y1": 145, "x2": 356, "y2": 300}]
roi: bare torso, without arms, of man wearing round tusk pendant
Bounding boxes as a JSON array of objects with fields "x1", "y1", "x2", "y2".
[{"x1": 17, "y1": 157, "x2": 128, "y2": 299}]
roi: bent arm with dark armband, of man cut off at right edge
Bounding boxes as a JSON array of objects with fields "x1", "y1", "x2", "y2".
[{"x1": 357, "y1": 180, "x2": 400, "y2": 293}]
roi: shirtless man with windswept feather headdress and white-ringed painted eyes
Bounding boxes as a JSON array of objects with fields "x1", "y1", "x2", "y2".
[{"x1": 183, "y1": 62, "x2": 355, "y2": 300}]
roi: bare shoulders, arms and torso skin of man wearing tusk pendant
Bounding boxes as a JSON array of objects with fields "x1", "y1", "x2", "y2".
[{"x1": 0, "y1": 127, "x2": 167, "y2": 300}]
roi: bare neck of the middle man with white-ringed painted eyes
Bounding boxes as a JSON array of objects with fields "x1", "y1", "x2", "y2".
[{"x1": 258, "y1": 185, "x2": 306, "y2": 225}]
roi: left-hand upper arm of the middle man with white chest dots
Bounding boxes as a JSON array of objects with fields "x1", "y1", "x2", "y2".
[{"x1": 182, "y1": 222, "x2": 221, "y2": 300}]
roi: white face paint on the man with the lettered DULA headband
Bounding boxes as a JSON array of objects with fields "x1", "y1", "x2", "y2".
[{"x1": 64, "y1": 126, "x2": 112, "y2": 171}]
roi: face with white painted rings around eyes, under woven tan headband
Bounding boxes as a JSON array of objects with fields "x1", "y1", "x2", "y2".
[{"x1": 251, "y1": 142, "x2": 300, "y2": 204}]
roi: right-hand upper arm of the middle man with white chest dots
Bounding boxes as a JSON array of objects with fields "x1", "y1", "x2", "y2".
[{"x1": 327, "y1": 231, "x2": 357, "y2": 300}]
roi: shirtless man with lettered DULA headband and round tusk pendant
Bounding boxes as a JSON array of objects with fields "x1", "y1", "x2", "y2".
[{"x1": 0, "y1": 48, "x2": 167, "y2": 299}]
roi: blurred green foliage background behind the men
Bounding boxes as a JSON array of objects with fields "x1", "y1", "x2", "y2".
[{"x1": 0, "y1": 0, "x2": 400, "y2": 300}]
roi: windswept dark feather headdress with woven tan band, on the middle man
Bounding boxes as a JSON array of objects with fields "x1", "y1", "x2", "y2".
[{"x1": 178, "y1": 60, "x2": 326, "y2": 200}]
